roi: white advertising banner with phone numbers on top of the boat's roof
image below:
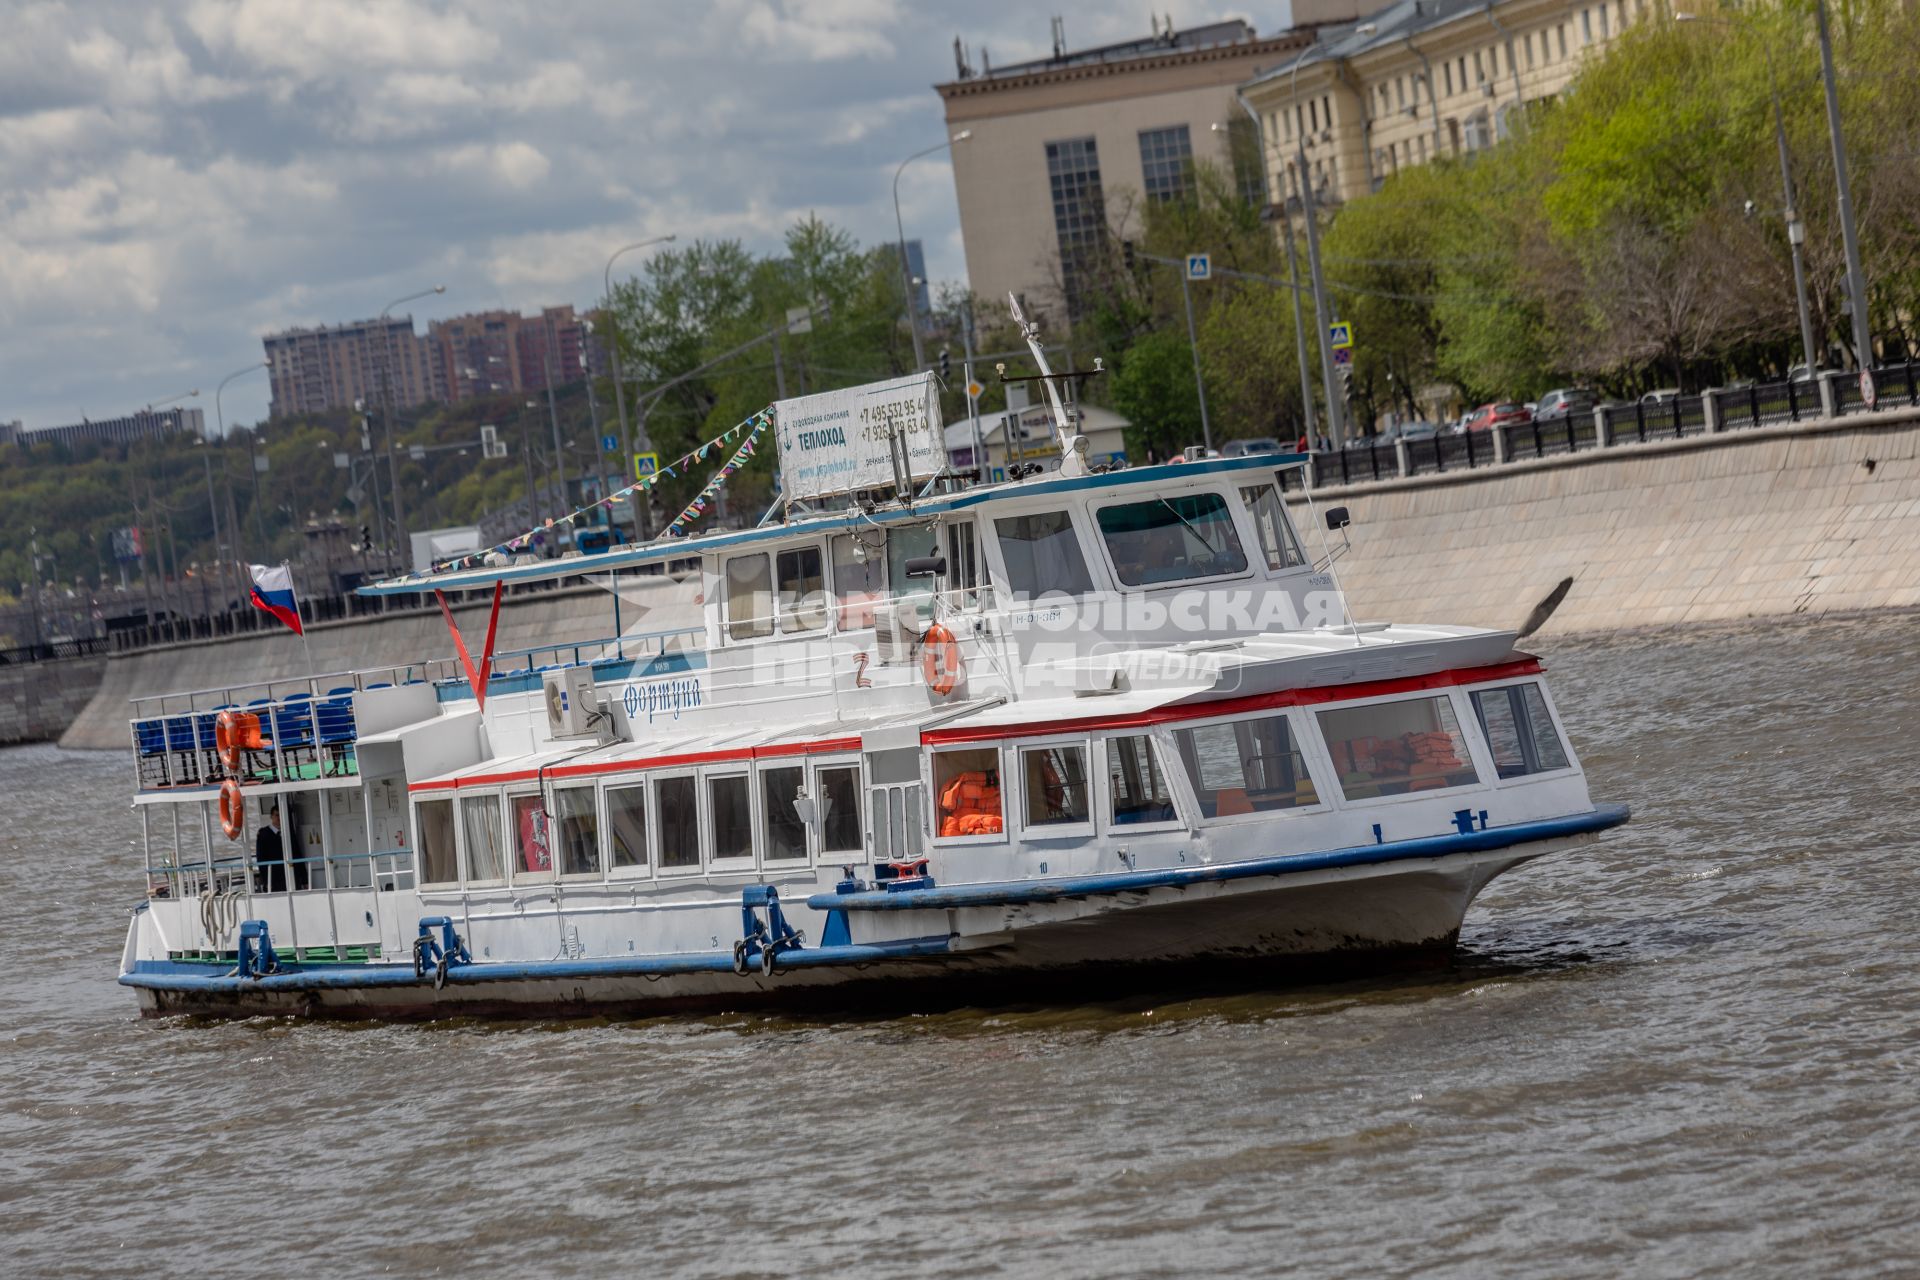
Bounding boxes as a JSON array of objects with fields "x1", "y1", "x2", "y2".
[{"x1": 774, "y1": 370, "x2": 947, "y2": 501}]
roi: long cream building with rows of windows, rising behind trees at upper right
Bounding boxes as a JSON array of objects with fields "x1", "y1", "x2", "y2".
[{"x1": 1242, "y1": 0, "x2": 1649, "y2": 207}]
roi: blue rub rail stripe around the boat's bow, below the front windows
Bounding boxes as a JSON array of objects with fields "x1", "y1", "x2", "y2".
[{"x1": 806, "y1": 804, "x2": 1628, "y2": 912}]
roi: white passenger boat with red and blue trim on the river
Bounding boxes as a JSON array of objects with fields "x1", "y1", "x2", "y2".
[{"x1": 119, "y1": 318, "x2": 1626, "y2": 1017}]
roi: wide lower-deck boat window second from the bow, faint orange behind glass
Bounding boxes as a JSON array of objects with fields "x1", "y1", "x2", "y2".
[{"x1": 1319, "y1": 695, "x2": 1478, "y2": 800}]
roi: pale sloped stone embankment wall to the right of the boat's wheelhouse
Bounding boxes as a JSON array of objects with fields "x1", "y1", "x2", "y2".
[{"x1": 1292, "y1": 409, "x2": 1920, "y2": 633}]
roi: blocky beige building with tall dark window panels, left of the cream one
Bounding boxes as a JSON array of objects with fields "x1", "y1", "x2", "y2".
[{"x1": 935, "y1": 14, "x2": 1359, "y2": 326}]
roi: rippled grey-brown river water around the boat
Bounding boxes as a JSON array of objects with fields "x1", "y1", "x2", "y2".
[{"x1": 0, "y1": 618, "x2": 1920, "y2": 1278}]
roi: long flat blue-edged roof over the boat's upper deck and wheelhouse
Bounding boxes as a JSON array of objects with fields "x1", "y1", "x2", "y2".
[{"x1": 357, "y1": 453, "x2": 1308, "y2": 595}]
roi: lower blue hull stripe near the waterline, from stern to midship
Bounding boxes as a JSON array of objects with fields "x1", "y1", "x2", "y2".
[{"x1": 119, "y1": 936, "x2": 948, "y2": 992}]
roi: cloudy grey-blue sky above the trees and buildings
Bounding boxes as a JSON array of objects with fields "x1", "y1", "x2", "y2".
[{"x1": 0, "y1": 0, "x2": 1288, "y2": 426}]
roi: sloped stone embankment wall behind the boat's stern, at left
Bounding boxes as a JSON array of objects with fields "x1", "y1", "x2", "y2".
[{"x1": 58, "y1": 576, "x2": 701, "y2": 750}]
